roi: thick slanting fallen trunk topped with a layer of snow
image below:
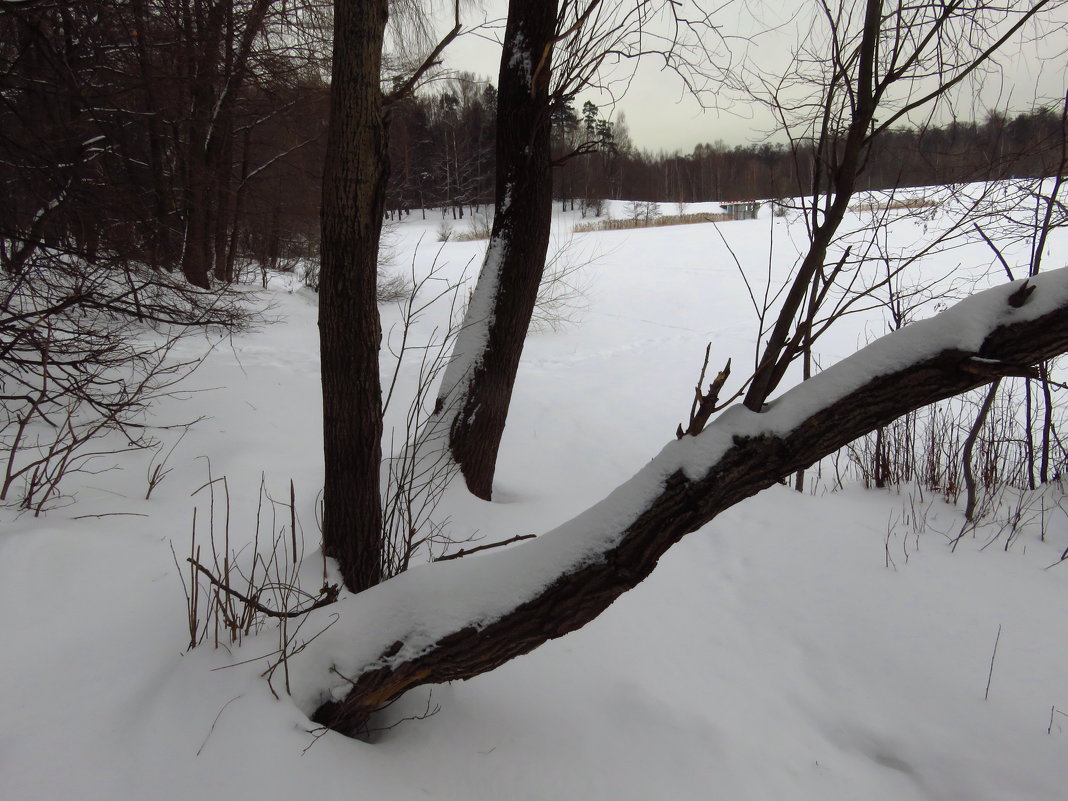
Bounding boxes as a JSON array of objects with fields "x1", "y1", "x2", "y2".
[{"x1": 314, "y1": 270, "x2": 1068, "y2": 733}]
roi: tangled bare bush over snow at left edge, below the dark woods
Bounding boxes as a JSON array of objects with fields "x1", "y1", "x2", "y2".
[{"x1": 0, "y1": 246, "x2": 250, "y2": 515}]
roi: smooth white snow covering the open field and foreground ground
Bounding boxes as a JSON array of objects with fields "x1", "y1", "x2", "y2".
[{"x1": 0, "y1": 191, "x2": 1068, "y2": 801}]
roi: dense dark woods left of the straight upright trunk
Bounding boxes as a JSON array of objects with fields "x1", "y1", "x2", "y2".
[{"x1": 0, "y1": 0, "x2": 327, "y2": 287}]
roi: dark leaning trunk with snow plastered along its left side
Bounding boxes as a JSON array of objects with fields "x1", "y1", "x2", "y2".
[{"x1": 438, "y1": 0, "x2": 557, "y2": 500}]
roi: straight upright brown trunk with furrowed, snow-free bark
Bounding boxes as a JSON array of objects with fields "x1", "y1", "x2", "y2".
[{"x1": 319, "y1": 0, "x2": 389, "y2": 592}]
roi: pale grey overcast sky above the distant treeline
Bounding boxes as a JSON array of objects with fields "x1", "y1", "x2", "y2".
[{"x1": 425, "y1": 0, "x2": 1068, "y2": 153}]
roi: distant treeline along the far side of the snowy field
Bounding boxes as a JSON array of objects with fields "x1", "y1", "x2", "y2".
[{"x1": 388, "y1": 76, "x2": 1065, "y2": 217}]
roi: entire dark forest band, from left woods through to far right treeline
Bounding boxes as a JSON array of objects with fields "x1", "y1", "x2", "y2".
[{"x1": 0, "y1": 0, "x2": 1065, "y2": 285}]
